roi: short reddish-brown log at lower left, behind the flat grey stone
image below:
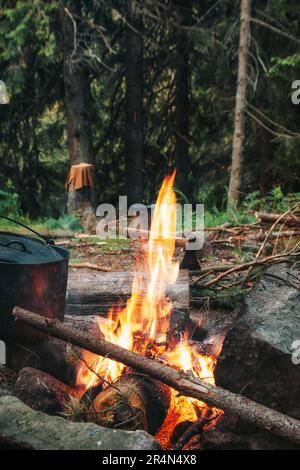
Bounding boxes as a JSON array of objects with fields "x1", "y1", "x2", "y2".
[{"x1": 15, "y1": 367, "x2": 73, "y2": 414}]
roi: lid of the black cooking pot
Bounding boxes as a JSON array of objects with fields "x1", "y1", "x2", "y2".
[{"x1": 0, "y1": 232, "x2": 64, "y2": 264}]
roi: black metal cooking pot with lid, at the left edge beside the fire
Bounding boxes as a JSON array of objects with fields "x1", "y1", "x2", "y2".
[{"x1": 0, "y1": 216, "x2": 69, "y2": 340}]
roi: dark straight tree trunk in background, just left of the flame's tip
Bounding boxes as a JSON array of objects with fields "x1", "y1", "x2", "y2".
[{"x1": 125, "y1": 0, "x2": 144, "y2": 205}]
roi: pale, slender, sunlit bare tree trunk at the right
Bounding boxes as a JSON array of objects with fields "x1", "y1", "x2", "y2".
[{"x1": 228, "y1": 0, "x2": 251, "y2": 207}]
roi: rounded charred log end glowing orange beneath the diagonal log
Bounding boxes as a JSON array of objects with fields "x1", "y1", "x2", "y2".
[{"x1": 94, "y1": 374, "x2": 171, "y2": 435}]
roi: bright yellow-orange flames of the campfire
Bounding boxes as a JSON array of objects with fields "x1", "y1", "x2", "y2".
[{"x1": 77, "y1": 172, "x2": 221, "y2": 446}]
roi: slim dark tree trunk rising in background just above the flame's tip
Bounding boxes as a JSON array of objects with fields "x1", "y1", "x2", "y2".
[{"x1": 174, "y1": 0, "x2": 191, "y2": 195}]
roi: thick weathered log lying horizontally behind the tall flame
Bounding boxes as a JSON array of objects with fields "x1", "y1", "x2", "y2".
[{"x1": 66, "y1": 269, "x2": 189, "y2": 315}]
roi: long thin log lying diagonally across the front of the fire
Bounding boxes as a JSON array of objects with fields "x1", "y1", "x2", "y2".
[{"x1": 13, "y1": 307, "x2": 300, "y2": 445}]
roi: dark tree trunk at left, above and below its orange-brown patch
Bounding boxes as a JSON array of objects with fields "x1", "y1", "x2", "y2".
[{"x1": 60, "y1": 0, "x2": 93, "y2": 218}]
